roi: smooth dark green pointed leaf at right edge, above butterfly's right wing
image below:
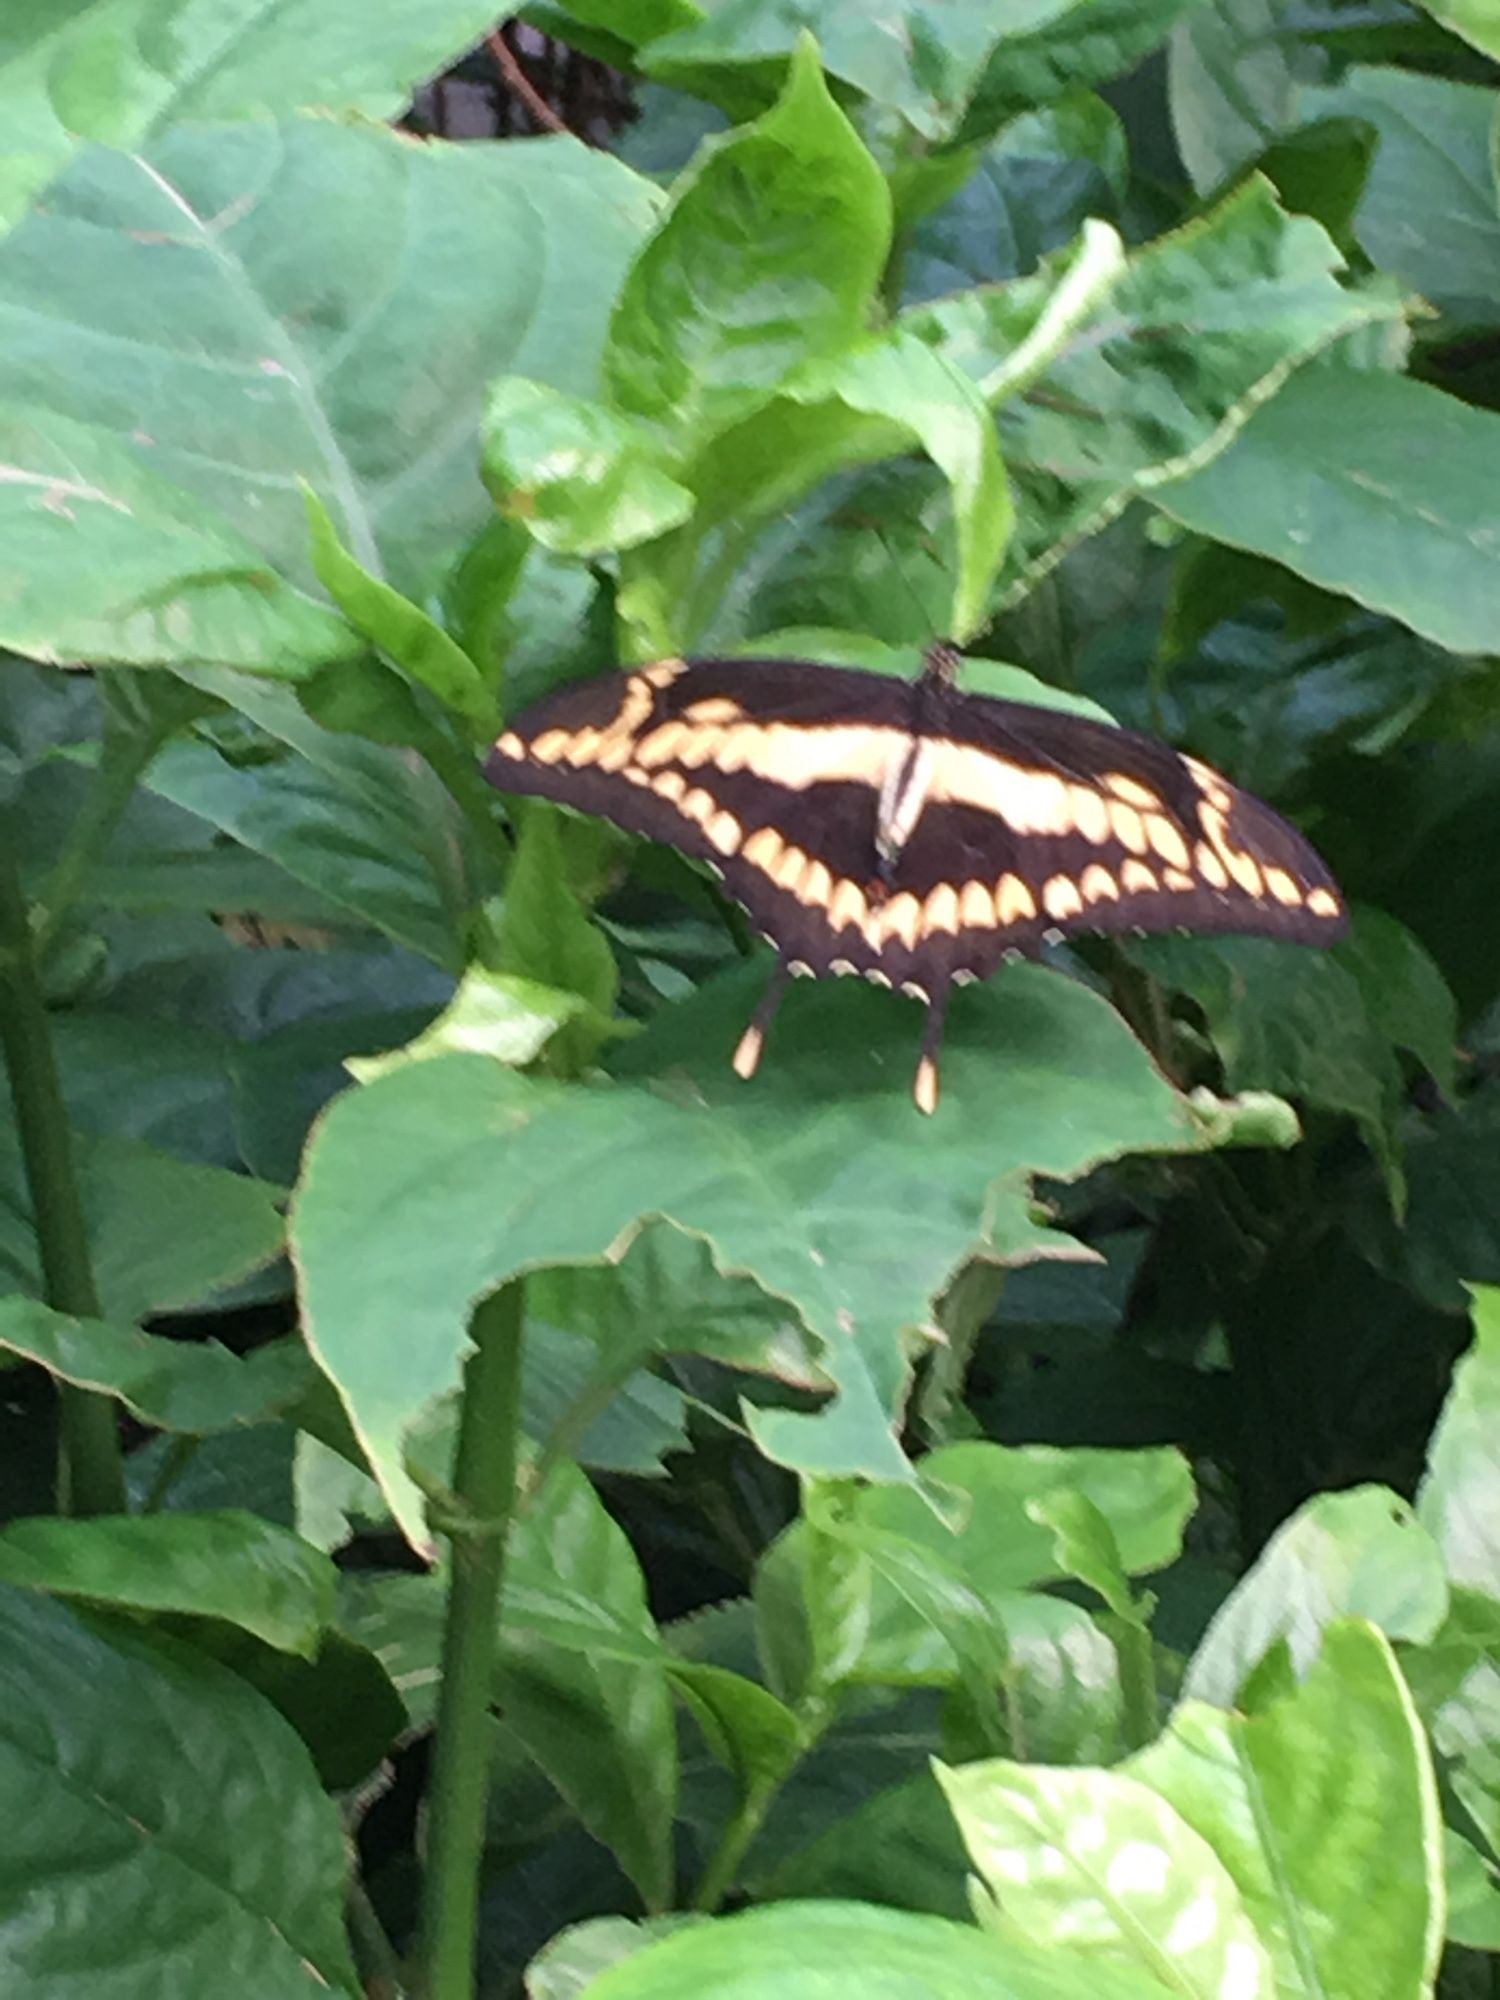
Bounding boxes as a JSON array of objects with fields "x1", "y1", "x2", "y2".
[{"x1": 1152, "y1": 368, "x2": 1500, "y2": 652}]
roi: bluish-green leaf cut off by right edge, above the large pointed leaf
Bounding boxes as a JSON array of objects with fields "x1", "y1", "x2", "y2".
[{"x1": 1304, "y1": 68, "x2": 1500, "y2": 324}]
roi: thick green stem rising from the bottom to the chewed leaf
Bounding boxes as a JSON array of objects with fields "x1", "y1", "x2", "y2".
[{"x1": 418, "y1": 1284, "x2": 524, "y2": 2000}]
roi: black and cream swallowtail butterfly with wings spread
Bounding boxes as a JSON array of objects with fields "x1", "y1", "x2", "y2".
[{"x1": 484, "y1": 644, "x2": 1348, "y2": 1112}]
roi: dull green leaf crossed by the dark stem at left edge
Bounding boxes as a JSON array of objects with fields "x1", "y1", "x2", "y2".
[{"x1": 0, "y1": 1120, "x2": 282, "y2": 1324}]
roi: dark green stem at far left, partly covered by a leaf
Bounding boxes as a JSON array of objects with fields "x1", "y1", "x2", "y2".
[{"x1": 0, "y1": 822, "x2": 126, "y2": 1514}]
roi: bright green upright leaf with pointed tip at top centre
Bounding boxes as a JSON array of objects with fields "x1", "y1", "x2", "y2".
[{"x1": 604, "y1": 40, "x2": 890, "y2": 442}]
